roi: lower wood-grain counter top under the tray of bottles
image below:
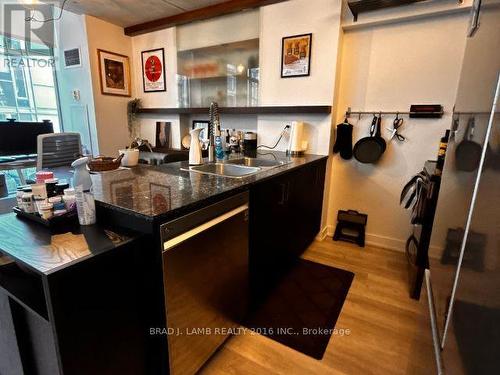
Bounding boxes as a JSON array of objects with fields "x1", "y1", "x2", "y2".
[{"x1": 0, "y1": 213, "x2": 138, "y2": 275}]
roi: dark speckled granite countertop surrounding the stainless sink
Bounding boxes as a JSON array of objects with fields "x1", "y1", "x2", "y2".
[{"x1": 92, "y1": 151, "x2": 326, "y2": 221}]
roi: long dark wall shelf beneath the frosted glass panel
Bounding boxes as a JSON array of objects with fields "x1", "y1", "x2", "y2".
[{"x1": 138, "y1": 105, "x2": 332, "y2": 115}]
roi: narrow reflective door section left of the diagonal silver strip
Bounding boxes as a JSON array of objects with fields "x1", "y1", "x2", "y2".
[{"x1": 429, "y1": 0, "x2": 500, "y2": 347}]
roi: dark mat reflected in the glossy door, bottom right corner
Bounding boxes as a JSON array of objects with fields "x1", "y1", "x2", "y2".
[{"x1": 452, "y1": 300, "x2": 500, "y2": 374}]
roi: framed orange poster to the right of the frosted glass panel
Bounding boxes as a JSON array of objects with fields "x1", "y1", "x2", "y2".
[{"x1": 281, "y1": 34, "x2": 312, "y2": 78}]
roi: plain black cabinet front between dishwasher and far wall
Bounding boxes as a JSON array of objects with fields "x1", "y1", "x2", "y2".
[{"x1": 249, "y1": 159, "x2": 326, "y2": 294}]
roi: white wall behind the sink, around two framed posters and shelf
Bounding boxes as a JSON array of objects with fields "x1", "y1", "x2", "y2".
[{"x1": 132, "y1": 0, "x2": 341, "y2": 155}]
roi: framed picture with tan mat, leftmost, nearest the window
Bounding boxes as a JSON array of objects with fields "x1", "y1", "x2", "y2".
[{"x1": 97, "y1": 49, "x2": 131, "y2": 96}]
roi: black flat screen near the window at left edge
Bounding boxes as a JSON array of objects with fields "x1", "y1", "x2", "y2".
[{"x1": 0, "y1": 121, "x2": 54, "y2": 156}]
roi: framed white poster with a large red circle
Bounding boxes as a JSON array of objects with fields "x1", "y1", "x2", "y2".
[{"x1": 141, "y1": 48, "x2": 167, "y2": 92}]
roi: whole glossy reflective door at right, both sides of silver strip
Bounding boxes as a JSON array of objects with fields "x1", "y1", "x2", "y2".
[{"x1": 429, "y1": 0, "x2": 500, "y2": 374}]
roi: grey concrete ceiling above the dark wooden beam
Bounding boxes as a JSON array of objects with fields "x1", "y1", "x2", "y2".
[{"x1": 56, "y1": 0, "x2": 227, "y2": 27}]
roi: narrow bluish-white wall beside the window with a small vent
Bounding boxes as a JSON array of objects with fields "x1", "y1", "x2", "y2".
[{"x1": 55, "y1": 11, "x2": 99, "y2": 155}]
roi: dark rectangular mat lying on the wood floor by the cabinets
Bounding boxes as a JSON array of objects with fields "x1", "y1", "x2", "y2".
[{"x1": 246, "y1": 259, "x2": 354, "y2": 359}]
